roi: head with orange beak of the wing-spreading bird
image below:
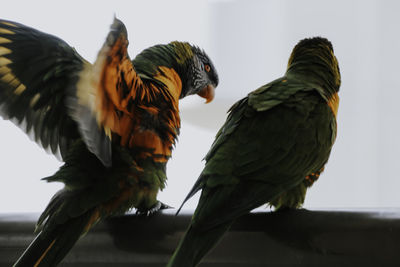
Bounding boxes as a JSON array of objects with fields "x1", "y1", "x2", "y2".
[{"x1": 171, "y1": 42, "x2": 219, "y2": 103}]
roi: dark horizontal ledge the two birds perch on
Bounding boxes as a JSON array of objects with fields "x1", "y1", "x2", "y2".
[{"x1": 0, "y1": 209, "x2": 400, "y2": 267}]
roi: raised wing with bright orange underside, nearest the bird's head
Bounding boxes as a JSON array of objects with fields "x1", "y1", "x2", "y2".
[{"x1": 67, "y1": 19, "x2": 147, "y2": 166}]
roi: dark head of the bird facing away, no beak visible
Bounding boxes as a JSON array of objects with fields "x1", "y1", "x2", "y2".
[{"x1": 287, "y1": 37, "x2": 341, "y2": 92}]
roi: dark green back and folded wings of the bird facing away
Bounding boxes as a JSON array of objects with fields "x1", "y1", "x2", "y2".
[{"x1": 185, "y1": 79, "x2": 335, "y2": 229}]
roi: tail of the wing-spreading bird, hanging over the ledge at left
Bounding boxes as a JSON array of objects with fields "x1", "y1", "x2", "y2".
[{"x1": 14, "y1": 212, "x2": 92, "y2": 267}]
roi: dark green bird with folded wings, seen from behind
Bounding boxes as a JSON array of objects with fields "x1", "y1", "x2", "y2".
[{"x1": 168, "y1": 37, "x2": 340, "y2": 267}]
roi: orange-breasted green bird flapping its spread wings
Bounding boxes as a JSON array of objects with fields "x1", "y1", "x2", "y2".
[{"x1": 0, "y1": 19, "x2": 218, "y2": 266}]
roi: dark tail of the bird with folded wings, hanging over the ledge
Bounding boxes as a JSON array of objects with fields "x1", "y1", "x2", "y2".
[{"x1": 167, "y1": 222, "x2": 232, "y2": 267}]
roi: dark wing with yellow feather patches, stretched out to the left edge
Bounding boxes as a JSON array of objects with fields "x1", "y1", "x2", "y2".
[{"x1": 0, "y1": 20, "x2": 85, "y2": 161}]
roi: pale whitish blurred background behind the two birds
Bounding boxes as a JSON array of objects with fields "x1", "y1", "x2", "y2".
[{"x1": 0, "y1": 0, "x2": 400, "y2": 213}]
